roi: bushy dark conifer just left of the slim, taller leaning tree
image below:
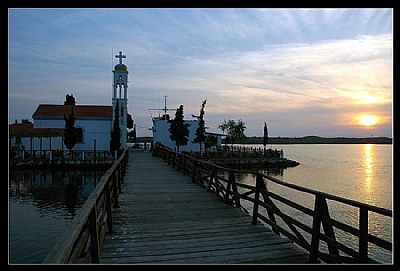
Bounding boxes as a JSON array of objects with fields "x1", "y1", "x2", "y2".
[{"x1": 168, "y1": 105, "x2": 189, "y2": 152}]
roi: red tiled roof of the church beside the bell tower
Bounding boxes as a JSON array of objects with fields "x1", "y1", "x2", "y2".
[{"x1": 32, "y1": 104, "x2": 113, "y2": 119}]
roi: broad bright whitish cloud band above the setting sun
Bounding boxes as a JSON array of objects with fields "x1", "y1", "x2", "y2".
[{"x1": 155, "y1": 32, "x2": 391, "y2": 106}]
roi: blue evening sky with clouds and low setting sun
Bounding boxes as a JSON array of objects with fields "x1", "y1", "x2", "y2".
[{"x1": 8, "y1": 8, "x2": 393, "y2": 137}]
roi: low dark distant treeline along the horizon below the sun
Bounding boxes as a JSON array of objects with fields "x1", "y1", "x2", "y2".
[{"x1": 137, "y1": 136, "x2": 392, "y2": 144}]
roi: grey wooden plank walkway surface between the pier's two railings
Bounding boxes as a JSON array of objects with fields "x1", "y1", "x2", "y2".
[{"x1": 100, "y1": 149, "x2": 309, "y2": 264}]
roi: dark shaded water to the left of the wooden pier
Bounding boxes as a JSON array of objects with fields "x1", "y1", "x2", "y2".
[{"x1": 9, "y1": 170, "x2": 105, "y2": 264}]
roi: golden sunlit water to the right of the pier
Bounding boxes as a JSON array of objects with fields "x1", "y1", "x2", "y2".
[{"x1": 233, "y1": 144, "x2": 393, "y2": 263}]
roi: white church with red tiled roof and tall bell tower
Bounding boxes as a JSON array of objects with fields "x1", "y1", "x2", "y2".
[{"x1": 9, "y1": 52, "x2": 128, "y2": 151}]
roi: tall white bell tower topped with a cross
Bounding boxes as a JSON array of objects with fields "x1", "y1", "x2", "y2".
[{"x1": 112, "y1": 51, "x2": 128, "y2": 149}]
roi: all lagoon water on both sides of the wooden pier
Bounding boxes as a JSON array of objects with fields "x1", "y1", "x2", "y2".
[{"x1": 9, "y1": 144, "x2": 393, "y2": 264}]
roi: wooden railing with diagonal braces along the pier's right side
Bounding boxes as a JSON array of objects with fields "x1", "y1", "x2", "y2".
[{"x1": 153, "y1": 145, "x2": 393, "y2": 263}]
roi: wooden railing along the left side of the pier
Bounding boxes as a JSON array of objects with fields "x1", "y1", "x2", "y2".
[{"x1": 42, "y1": 149, "x2": 129, "y2": 264}]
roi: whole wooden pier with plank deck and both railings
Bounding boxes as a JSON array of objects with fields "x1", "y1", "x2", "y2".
[{"x1": 43, "y1": 146, "x2": 393, "y2": 264}]
